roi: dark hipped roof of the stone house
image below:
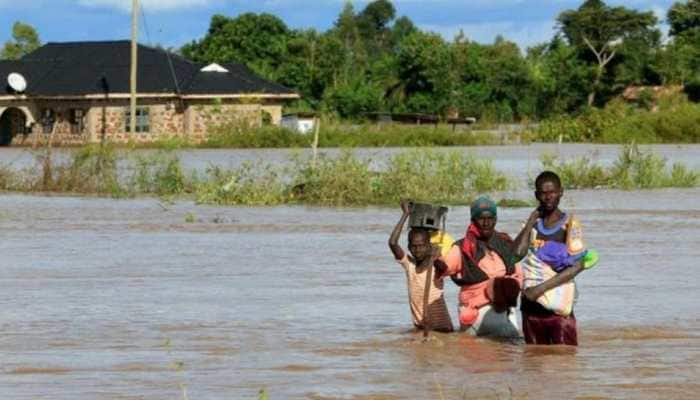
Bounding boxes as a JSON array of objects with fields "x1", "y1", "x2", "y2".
[{"x1": 0, "y1": 40, "x2": 294, "y2": 96}]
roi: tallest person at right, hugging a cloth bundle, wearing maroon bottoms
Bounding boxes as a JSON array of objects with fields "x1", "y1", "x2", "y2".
[{"x1": 515, "y1": 171, "x2": 598, "y2": 346}]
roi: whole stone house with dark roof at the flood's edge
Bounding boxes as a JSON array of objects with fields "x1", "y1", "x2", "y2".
[{"x1": 0, "y1": 40, "x2": 299, "y2": 145}]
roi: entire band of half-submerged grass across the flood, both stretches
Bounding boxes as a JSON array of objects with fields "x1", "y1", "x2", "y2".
[{"x1": 0, "y1": 141, "x2": 700, "y2": 202}]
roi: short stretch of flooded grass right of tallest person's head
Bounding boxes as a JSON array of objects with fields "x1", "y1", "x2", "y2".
[{"x1": 542, "y1": 144, "x2": 700, "y2": 190}]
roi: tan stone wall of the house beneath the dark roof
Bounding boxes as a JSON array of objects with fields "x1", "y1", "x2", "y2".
[{"x1": 0, "y1": 99, "x2": 282, "y2": 145}]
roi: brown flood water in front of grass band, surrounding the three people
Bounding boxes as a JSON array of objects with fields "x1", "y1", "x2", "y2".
[{"x1": 0, "y1": 148, "x2": 700, "y2": 400}]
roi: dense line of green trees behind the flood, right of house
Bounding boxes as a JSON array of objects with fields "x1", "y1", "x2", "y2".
[{"x1": 181, "y1": 0, "x2": 700, "y2": 122}]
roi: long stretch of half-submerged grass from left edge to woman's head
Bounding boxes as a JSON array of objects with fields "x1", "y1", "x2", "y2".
[{"x1": 0, "y1": 146, "x2": 509, "y2": 205}]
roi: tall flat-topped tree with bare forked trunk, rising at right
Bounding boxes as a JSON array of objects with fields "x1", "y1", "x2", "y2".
[{"x1": 557, "y1": 0, "x2": 657, "y2": 106}]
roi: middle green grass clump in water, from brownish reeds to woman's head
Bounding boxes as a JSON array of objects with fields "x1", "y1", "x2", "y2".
[{"x1": 196, "y1": 149, "x2": 509, "y2": 206}]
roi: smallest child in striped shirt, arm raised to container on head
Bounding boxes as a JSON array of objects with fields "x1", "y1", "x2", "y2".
[{"x1": 389, "y1": 200, "x2": 454, "y2": 332}]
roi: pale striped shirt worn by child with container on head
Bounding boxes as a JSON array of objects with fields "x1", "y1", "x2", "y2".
[{"x1": 397, "y1": 255, "x2": 454, "y2": 332}]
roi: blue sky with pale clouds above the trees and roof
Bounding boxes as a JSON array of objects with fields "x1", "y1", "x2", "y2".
[{"x1": 0, "y1": 0, "x2": 674, "y2": 47}]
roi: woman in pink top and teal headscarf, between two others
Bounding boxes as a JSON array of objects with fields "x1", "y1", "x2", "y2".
[{"x1": 436, "y1": 196, "x2": 523, "y2": 337}]
